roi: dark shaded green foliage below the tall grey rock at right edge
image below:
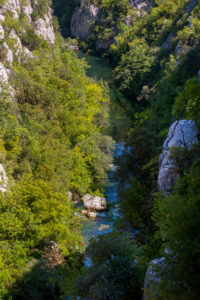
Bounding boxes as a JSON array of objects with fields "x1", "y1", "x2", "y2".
[{"x1": 154, "y1": 165, "x2": 200, "y2": 299}]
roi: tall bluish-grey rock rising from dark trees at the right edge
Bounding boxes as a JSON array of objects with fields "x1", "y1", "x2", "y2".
[{"x1": 158, "y1": 120, "x2": 198, "y2": 193}]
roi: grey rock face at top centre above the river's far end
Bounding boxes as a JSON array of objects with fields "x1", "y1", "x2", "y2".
[{"x1": 71, "y1": 1, "x2": 100, "y2": 40}]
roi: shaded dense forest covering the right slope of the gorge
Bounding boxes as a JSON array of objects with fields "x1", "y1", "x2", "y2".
[{"x1": 55, "y1": 0, "x2": 200, "y2": 299}]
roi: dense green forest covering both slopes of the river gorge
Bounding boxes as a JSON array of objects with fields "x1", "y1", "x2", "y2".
[{"x1": 0, "y1": 0, "x2": 200, "y2": 300}]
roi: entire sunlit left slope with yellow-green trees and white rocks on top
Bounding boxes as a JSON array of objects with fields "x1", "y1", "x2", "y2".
[{"x1": 0, "y1": 0, "x2": 112, "y2": 299}]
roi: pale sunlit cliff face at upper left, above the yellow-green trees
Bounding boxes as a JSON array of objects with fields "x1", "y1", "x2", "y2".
[{"x1": 0, "y1": 0, "x2": 55, "y2": 192}]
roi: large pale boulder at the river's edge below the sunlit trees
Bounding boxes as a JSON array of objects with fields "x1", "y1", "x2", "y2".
[{"x1": 82, "y1": 194, "x2": 107, "y2": 211}]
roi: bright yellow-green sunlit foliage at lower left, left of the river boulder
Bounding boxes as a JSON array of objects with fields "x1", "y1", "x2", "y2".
[{"x1": 0, "y1": 177, "x2": 82, "y2": 297}]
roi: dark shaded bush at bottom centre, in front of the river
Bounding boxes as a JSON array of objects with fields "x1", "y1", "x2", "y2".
[{"x1": 76, "y1": 235, "x2": 143, "y2": 299}]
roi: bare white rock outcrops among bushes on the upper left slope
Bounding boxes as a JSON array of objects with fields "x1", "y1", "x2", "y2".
[{"x1": 0, "y1": 0, "x2": 55, "y2": 192}]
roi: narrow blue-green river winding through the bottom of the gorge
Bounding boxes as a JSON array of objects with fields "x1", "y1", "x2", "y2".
[{"x1": 79, "y1": 52, "x2": 130, "y2": 266}]
